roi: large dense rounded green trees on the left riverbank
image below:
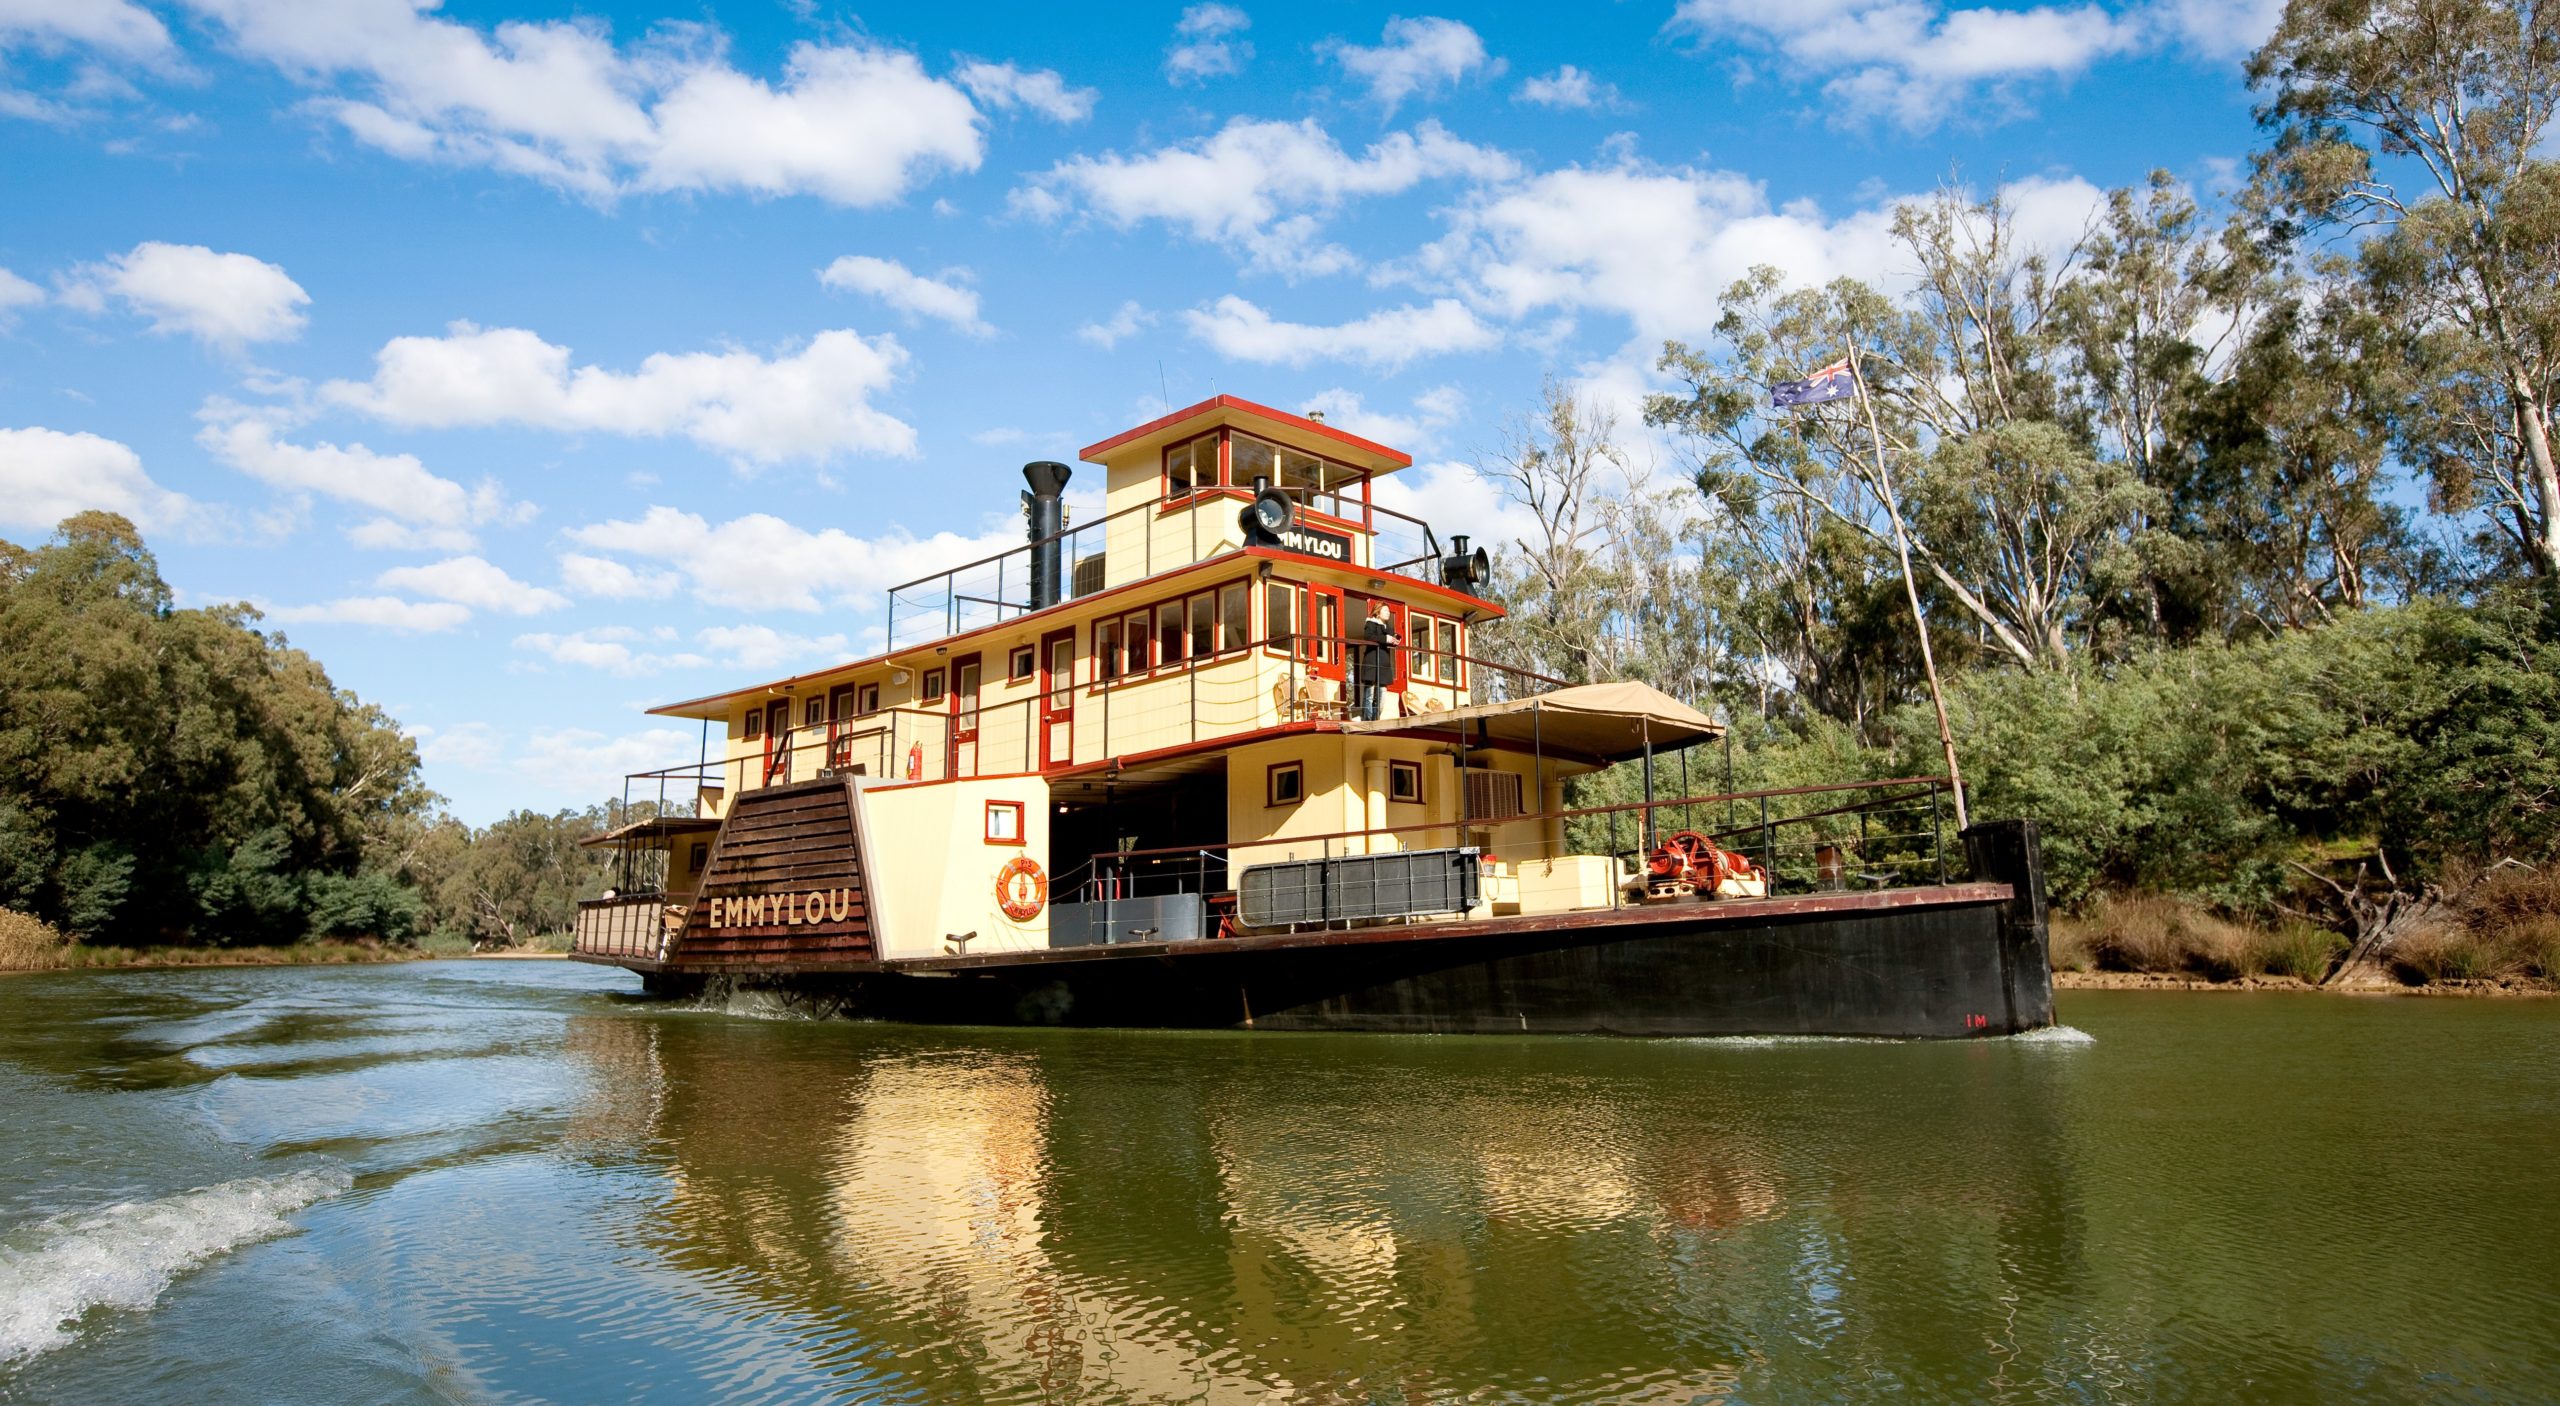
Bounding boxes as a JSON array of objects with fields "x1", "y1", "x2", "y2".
[{"x1": 0, "y1": 512, "x2": 433, "y2": 942}]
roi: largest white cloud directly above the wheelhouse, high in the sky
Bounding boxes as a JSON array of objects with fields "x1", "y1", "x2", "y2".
[{"x1": 1014, "y1": 118, "x2": 1518, "y2": 274}]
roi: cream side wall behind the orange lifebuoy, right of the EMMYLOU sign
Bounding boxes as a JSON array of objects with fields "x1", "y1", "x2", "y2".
[{"x1": 858, "y1": 776, "x2": 1055, "y2": 958}]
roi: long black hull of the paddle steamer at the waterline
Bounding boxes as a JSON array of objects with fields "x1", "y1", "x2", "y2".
[{"x1": 604, "y1": 825, "x2": 2053, "y2": 1037}]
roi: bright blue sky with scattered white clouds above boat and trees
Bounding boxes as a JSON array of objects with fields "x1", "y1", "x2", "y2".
[{"x1": 0, "y1": 0, "x2": 2271, "y2": 822}]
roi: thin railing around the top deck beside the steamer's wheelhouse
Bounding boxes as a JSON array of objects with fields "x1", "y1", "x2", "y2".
[{"x1": 886, "y1": 489, "x2": 1441, "y2": 650}]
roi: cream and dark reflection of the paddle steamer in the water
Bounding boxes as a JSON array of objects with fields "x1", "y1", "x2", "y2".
[{"x1": 571, "y1": 1014, "x2": 2076, "y2": 1401}]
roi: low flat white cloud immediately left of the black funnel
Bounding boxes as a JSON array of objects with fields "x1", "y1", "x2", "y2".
[{"x1": 568, "y1": 507, "x2": 1021, "y2": 610}]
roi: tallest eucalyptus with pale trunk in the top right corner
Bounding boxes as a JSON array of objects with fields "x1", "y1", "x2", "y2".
[{"x1": 2248, "y1": 0, "x2": 2560, "y2": 576}]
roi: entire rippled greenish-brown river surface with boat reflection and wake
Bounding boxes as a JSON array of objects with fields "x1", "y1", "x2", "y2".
[{"x1": 0, "y1": 963, "x2": 2560, "y2": 1403}]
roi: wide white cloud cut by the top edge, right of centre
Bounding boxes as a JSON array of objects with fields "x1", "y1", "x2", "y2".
[{"x1": 1672, "y1": 0, "x2": 2150, "y2": 131}]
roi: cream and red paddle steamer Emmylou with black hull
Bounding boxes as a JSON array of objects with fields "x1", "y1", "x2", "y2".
[{"x1": 576, "y1": 394, "x2": 2053, "y2": 1035}]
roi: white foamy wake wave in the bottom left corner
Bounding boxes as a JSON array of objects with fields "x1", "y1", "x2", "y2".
[{"x1": 0, "y1": 1170, "x2": 348, "y2": 1365}]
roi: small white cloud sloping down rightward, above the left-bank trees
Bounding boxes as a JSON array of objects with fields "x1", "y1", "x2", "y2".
[{"x1": 195, "y1": 397, "x2": 530, "y2": 530}]
